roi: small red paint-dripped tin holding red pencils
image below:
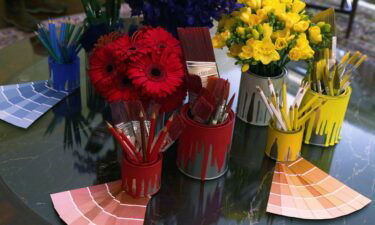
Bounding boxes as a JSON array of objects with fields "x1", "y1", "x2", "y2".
[{"x1": 122, "y1": 154, "x2": 163, "y2": 198}]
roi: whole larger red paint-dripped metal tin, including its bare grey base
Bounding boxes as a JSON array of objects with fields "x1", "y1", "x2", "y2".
[{"x1": 177, "y1": 105, "x2": 234, "y2": 181}]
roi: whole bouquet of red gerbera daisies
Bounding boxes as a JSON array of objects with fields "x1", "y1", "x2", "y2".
[{"x1": 89, "y1": 27, "x2": 186, "y2": 112}]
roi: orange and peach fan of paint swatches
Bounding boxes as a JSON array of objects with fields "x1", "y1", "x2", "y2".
[{"x1": 267, "y1": 157, "x2": 371, "y2": 220}]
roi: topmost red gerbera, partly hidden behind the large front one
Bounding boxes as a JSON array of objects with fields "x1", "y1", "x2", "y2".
[{"x1": 136, "y1": 27, "x2": 182, "y2": 55}]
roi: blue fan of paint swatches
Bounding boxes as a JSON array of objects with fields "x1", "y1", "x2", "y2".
[{"x1": 0, "y1": 80, "x2": 70, "y2": 128}]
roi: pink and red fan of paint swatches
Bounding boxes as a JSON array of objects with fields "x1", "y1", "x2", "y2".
[{"x1": 51, "y1": 180, "x2": 150, "y2": 225}]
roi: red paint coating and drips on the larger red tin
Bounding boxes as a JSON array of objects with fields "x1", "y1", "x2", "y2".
[{"x1": 177, "y1": 106, "x2": 234, "y2": 180}]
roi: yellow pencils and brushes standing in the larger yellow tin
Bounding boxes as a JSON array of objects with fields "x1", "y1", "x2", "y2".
[{"x1": 307, "y1": 49, "x2": 367, "y2": 96}]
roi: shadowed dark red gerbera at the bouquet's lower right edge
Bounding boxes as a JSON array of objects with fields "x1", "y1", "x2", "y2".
[{"x1": 155, "y1": 84, "x2": 186, "y2": 112}]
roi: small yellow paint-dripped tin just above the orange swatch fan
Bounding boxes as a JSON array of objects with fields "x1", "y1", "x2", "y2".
[{"x1": 266, "y1": 123, "x2": 303, "y2": 162}]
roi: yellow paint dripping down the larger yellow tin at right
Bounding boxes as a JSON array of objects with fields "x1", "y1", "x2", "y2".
[{"x1": 301, "y1": 87, "x2": 352, "y2": 147}]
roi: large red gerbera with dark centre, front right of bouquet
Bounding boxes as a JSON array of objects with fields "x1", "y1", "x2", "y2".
[{"x1": 128, "y1": 49, "x2": 185, "y2": 98}]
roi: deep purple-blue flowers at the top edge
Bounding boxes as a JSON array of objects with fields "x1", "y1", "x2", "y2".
[{"x1": 125, "y1": 0, "x2": 240, "y2": 34}]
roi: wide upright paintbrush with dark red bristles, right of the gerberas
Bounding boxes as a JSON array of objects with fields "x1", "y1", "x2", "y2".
[{"x1": 177, "y1": 27, "x2": 219, "y2": 87}]
